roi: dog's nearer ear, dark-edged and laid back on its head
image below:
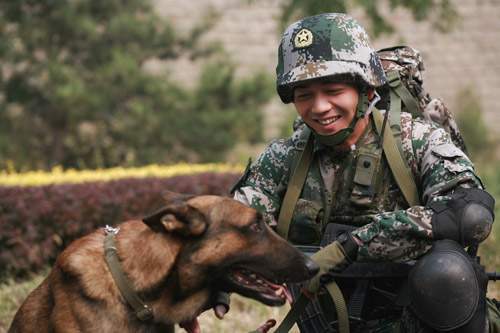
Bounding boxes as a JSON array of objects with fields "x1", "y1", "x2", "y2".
[{"x1": 142, "y1": 201, "x2": 207, "y2": 237}]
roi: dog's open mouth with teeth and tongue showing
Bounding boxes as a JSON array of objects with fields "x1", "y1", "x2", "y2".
[{"x1": 224, "y1": 268, "x2": 292, "y2": 305}]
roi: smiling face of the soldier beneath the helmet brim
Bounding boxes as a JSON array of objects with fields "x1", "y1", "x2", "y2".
[{"x1": 293, "y1": 81, "x2": 359, "y2": 135}]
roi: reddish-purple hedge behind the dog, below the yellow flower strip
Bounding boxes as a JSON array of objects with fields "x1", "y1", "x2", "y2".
[{"x1": 0, "y1": 173, "x2": 239, "y2": 278}]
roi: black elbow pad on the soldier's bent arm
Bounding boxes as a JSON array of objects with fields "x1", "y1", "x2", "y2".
[{"x1": 429, "y1": 188, "x2": 495, "y2": 246}]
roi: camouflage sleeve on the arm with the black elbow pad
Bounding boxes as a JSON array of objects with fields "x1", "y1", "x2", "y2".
[{"x1": 353, "y1": 117, "x2": 482, "y2": 262}]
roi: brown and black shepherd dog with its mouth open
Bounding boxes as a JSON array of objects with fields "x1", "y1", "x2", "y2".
[{"x1": 9, "y1": 193, "x2": 318, "y2": 333}]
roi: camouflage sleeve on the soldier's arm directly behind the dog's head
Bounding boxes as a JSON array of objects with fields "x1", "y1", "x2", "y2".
[{"x1": 234, "y1": 139, "x2": 294, "y2": 227}]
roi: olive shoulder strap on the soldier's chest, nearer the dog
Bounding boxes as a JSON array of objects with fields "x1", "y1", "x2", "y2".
[{"x1": 277, "y1": 129, "x2": 313, "y2": 239}]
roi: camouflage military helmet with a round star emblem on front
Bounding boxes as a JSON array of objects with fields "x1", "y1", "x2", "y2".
[{"x1": 276, "y1": 13, "x2": 386, "y2": 103}]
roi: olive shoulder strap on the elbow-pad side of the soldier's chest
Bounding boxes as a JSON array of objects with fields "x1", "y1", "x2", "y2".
[{"x1": 373, "y1": 108, "x2": 420, "y2": 206}]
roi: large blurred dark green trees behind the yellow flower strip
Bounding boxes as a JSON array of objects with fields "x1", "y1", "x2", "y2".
[{"x1": 0, "y1": 0, "x2": 269, "y2": 169}]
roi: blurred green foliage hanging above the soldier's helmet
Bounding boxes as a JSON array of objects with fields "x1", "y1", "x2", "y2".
[{"x1": 281, "y1": 0, "x2": 458, "y2": 37}]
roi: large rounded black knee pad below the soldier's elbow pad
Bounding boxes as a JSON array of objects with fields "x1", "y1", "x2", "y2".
[{"x1": 408, "y1": 240, "x2": 488, "y2": 333}]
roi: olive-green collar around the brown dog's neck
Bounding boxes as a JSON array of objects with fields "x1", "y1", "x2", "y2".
[{"x1": 104, "y1": 225, "x2": 154, "y2": 321}]
